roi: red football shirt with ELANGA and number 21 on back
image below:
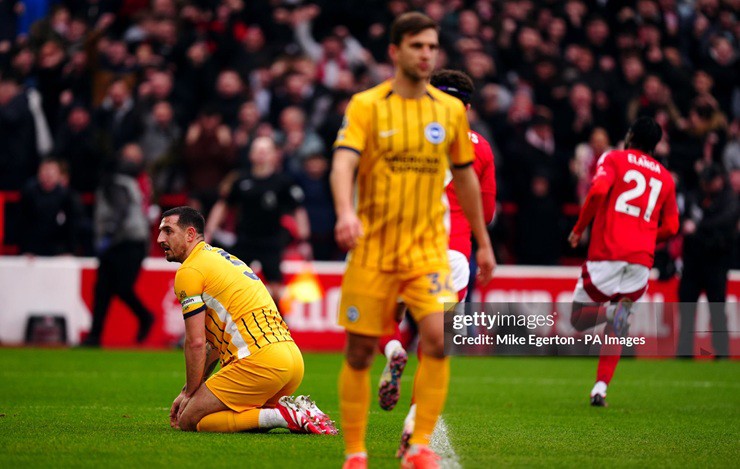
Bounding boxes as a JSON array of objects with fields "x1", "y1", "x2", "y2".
[{"x1": 573, "y1": 149, "x2": 678, "y2": 267}]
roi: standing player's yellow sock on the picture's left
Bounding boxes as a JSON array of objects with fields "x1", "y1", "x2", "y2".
[{"x1": 339, "y1": 360, "x2": 370, "y2": 454}]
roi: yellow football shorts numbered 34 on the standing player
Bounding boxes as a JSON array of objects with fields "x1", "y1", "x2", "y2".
[{"x1": 337, "y1": 263, "x2": 457, "y2": 337}]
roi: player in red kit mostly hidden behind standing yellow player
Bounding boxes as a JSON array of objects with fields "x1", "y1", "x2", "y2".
[{"x1": 378, "y1": 70, "x2": 496, "y2": 457}]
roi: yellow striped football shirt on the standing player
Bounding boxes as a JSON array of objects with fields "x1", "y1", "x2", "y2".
[{"x1": 334, "y1": 81, "x2": 474, "y2": 271}]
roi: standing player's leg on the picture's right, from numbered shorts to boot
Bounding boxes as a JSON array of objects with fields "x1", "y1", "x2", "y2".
[{"x1": 401, "y1": 265, "x2": 457, "y2": 463}]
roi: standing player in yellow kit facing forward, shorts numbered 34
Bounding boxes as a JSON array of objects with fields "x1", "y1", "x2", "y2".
[{"x1": 331, "y1": 13, "x2": 495, "y2": 467}]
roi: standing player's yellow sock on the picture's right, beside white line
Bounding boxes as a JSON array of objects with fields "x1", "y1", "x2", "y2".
[{"x1": 409, "y1": 355, "x2": 450, "y2": 445}]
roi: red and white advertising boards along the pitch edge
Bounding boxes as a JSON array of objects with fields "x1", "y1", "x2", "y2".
[{"x1": 0, "y1": 257, "x2": 740, "y2": 356}]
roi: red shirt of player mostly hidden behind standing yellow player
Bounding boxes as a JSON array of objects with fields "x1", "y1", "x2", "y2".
[{"x1": 445, "y1": 130, "x2": 496, "y2": 260}]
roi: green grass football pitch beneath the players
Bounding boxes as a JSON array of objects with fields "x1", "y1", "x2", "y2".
[{"x1": 0, "y1": 349, "x2": 740, "y2": 468}]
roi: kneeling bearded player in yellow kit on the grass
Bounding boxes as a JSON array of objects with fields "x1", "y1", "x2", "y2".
[{"x1": 157, "y1": 207, "x2": 337, "y2": 434}]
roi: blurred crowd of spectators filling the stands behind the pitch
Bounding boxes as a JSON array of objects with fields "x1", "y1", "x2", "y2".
[{"x1": 0, "y1": 0, "x2": 740, "y2": 270}]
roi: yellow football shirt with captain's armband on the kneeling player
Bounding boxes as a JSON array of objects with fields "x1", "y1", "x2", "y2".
[{"x1": 175, "y1": 242, "x2": 293, "y2": 366}]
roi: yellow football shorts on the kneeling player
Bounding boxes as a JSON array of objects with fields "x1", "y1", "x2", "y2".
[{"x1": 206, "y1": 342, "x2": 303, "y2": 412}]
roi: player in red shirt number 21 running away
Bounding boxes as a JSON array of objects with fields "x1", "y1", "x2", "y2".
[{"x1": 568, "y1": 117, "x2": 678, "y2": 406}]
